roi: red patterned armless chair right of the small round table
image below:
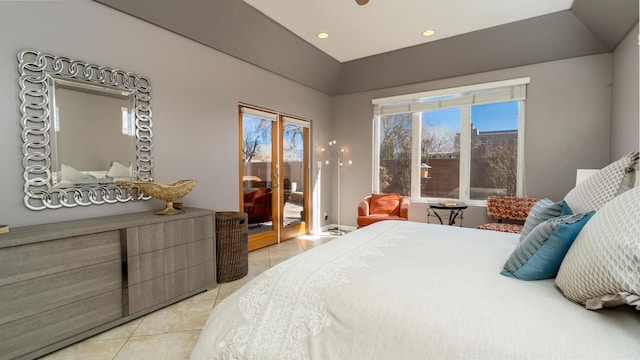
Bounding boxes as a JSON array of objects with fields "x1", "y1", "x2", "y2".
[{"x1": 476, "y1": 196, "x2": 540, "y2": 234}]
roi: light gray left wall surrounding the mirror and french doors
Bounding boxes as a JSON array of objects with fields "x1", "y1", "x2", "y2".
[{"x1": 0, "y1": 1, "x2": 332, "y2": 227}]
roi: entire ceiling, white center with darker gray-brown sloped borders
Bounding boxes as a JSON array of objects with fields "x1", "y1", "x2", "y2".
[{"x1": 94, "y1": 0, "x2": 639, "y2": 95}]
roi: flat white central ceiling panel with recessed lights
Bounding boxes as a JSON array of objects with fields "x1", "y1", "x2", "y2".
[{"x1": 244, "y1": 0, "x2": 573, "y2": 62}]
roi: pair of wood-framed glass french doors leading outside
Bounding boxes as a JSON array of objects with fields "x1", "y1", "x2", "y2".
[{"x1": 239, "y1": 105, "x2": 309, "y2": 251}]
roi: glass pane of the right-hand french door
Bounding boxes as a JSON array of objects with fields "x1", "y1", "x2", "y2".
[{"x1": 282, "y1": 123, "x2": 305, "y2": 227}]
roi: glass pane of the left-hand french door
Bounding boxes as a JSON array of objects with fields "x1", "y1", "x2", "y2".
[{"x1": 242, "y1": 114, "x2": 274, "y2": 235}]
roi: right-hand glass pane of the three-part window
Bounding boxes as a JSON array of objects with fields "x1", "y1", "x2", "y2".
[{"x1": 470, "y1": 101, "x2": 519, "y2": 200}]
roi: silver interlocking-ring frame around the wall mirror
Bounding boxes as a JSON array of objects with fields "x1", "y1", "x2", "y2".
[{"x1": 18, "y1": 50, "x2": 153, "y2": 210}]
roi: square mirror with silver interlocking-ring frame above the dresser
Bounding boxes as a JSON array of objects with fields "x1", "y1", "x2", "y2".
[{"x1": 18, "y1": 50, "x2": 153, "y2": 210}]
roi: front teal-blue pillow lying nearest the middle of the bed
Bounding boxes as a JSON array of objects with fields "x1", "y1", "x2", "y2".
[{"x1": 500, "y1": 211, "x2": 595, "y2": 280}]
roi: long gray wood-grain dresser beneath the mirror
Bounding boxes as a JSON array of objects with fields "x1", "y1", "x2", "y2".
[{"x1": 0, "y1": 208, "x2": 216, "y2": 360}]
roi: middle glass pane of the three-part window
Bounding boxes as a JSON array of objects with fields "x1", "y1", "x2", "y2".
[{"x1": 420, "y1": 108, "x2": 460, "y2": 199}]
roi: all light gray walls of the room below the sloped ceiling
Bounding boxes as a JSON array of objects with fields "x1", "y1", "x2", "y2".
[{"x1": 0, "y1": 1, "x2": 638, "y2": 232}]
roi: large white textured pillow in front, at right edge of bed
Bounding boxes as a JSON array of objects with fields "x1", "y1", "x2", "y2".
[{"x1": 556, "y1": 187, "x2": 640, "y2": 310}]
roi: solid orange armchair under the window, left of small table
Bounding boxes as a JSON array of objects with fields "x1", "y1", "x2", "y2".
[{"x1": 357, "y1": 194, "x2": 411, "y2": 228}]
